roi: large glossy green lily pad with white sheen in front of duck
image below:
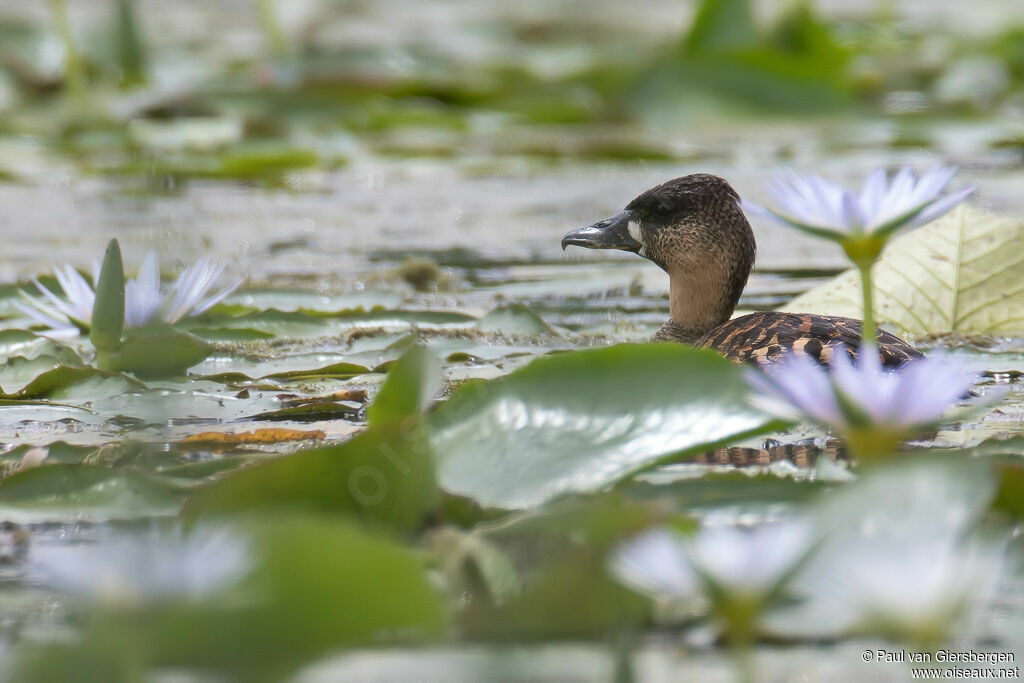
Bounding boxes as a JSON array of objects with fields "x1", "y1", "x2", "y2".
[{"x1": 430, "y1": 344, "x2": 772, "y2": 508}]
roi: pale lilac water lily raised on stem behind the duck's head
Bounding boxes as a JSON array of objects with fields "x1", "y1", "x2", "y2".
[{"x1": 742, "y1": 165, "x2": 976, "y2": 240}]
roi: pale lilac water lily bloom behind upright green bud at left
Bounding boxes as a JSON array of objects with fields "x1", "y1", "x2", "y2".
[{"x1": 14, "y1": 250, "x2": 243, "y2": 337}]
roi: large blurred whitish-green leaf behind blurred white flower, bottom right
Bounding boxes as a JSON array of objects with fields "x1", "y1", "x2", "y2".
[{"x1": 769, "y1": 453, "x2": 998, "y2": 639}]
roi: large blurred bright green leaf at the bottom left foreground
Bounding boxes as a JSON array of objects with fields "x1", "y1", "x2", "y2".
[{"x1": 148, "y1": 515, "x2": 446, "y2": 681}]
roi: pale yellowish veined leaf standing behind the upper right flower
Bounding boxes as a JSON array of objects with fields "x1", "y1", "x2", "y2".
[{"x1": 783, "y1": 206, "x2": 1024, "y2": 335}]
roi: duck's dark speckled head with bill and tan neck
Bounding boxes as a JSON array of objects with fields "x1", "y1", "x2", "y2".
[{"x1": 562, "y1": 173, "x2": 755, "y2": 334}]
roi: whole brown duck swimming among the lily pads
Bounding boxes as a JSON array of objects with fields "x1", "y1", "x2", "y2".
[{"x1": 561, "y1": 173, "x2": 922, "y2": 369}]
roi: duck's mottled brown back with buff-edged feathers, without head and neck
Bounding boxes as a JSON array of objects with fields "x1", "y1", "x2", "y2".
[{"x1": 688, "y1": 311, "x2": 921, "y2": 368}]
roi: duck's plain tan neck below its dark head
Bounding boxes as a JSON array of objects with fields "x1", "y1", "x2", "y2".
[{"x1": 658, "y1": 267, "x2": 745, "y2": 343}]
